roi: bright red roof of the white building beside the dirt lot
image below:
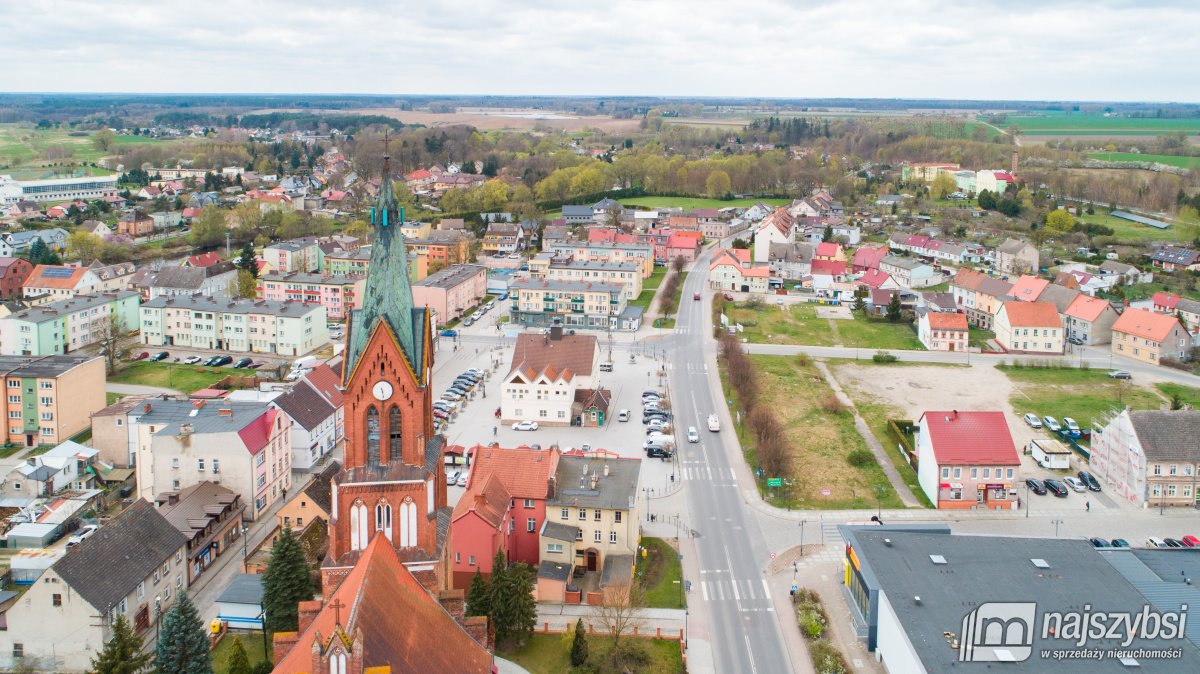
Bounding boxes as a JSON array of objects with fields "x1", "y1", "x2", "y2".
[{"x1": 918, "y1": 411, "x2": 1021, "y2": 465}]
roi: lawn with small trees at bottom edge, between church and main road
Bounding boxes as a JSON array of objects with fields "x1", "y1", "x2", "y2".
[{"x1": 496, "y1": 620, "x2": 684, "y2": 674}]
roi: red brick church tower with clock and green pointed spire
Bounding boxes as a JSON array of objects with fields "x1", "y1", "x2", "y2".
[{"x1": 322, "y1": 148, "x2": 450, "y2": 592}]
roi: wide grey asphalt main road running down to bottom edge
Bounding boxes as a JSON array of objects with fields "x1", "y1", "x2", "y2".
[{"x1": 667, "y1": 253, "x2": 793, "y2": 674}]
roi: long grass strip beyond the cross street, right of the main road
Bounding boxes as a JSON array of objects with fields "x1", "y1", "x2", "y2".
[{"x1": 726, "y1": 303, "x2": 924, "y2": 350}]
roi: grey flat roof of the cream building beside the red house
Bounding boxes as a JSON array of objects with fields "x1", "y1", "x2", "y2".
[{"x1": 551, "y1": 455, "x2": 642, "y2": 510}]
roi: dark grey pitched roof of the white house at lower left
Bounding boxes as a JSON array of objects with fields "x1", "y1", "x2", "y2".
[{"x1": 50, "y1": 499, "x2": 187, "y2": 613}]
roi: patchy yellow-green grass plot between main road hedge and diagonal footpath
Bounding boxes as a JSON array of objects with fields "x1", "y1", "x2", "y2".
[{"x1": 726, "y1": 355, "x2": 904, "y2": 510}]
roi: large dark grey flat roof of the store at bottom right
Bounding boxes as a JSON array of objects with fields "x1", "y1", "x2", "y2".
[{"x1": 841, "y1": 526, "x2": 1200, "y2": 674}]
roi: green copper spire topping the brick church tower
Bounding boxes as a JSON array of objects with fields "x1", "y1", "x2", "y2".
[{"x1": 346, "y1": 143, "x2": 425, "y2": 378}]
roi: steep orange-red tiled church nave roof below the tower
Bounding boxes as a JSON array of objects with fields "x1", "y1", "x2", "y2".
[{"x1": 272, "y1": 532, "x2": 493, "y2": 674}]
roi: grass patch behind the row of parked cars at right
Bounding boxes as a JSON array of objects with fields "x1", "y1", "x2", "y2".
[{"x1": 997, "y1": 366, "x2": 1166, "y2": 428}]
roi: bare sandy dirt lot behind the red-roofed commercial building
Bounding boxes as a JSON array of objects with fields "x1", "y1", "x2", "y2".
[{"x1": 834, "y1": 363, "x2": 1037, "y2": 449}]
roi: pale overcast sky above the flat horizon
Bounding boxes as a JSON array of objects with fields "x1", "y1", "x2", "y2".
[{"x1": 0, "y1": 0, "x2": 1200, "y2": 102}]
